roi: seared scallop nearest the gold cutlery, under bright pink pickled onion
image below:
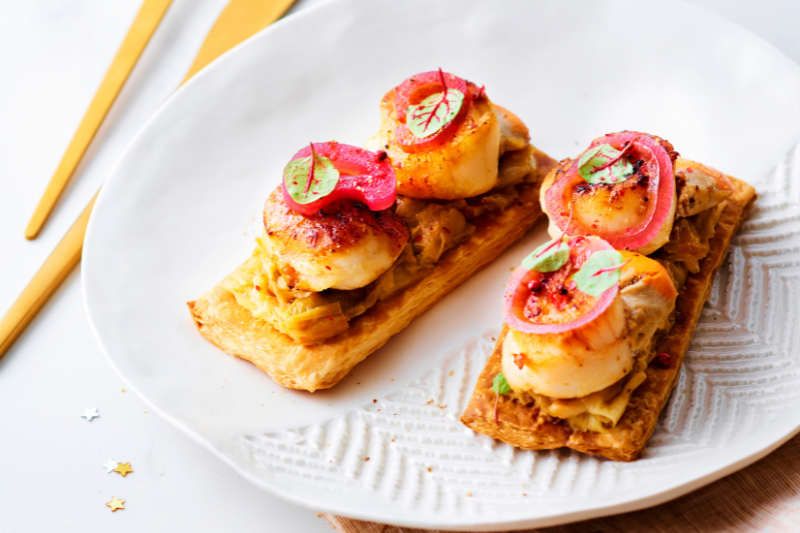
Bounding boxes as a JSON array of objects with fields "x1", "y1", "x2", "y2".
[{"x1": 264, "y1": 186, "x2": 409, "y2": 292}]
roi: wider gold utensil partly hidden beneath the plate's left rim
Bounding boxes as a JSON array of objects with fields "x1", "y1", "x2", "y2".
[{"x1": 0, "y1": 0, "x2": 294, "y2": 358}]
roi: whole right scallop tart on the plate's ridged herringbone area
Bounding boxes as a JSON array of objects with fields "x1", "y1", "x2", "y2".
[{"x1": 461, "y1": 132, "x2": 756, "y2": 461}]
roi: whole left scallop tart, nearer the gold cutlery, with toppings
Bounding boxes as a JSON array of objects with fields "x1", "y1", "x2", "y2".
[{"x1": 188, "y1": 70, "x2": 556, "y2": 392}]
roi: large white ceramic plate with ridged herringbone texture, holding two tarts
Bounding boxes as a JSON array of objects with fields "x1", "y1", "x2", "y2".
[{"x1": 83, "y1": 0, "x2": 800, "y2": 531}]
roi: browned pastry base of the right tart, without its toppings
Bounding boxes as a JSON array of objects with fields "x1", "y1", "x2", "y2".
[{"x1": 461, "y1": 178, "x2": 756, "y2": 461}]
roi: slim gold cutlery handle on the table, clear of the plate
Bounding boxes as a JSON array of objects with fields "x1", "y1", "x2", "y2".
[{"x1": 25, "y1": 0, "x2": 172, "y2": 239}]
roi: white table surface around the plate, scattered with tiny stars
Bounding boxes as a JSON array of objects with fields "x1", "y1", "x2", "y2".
[{"x1": 0, "y1": 0, "x2": 800, "y2": 533}]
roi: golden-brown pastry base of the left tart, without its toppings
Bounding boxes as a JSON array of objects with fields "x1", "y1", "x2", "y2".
[{"x1": 187, "y1": 150, "x2": 556, "y2": 392}]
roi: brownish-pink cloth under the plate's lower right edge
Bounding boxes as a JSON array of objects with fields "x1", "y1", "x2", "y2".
[{"x1": 323, "y1": 436, "x2": 800, "y2": 533}]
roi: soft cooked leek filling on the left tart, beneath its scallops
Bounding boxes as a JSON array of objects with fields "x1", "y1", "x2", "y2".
[{"x1": 222, "y1": 146, "x2": 536, "y2": 344}]
